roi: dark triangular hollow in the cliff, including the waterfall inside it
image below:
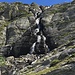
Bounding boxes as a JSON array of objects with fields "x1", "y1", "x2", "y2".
[{"x1": 3, "y1": 13, "x2": 58, "y2": 57}]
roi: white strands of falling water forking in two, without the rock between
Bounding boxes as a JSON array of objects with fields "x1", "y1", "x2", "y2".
[{"x1": 30, "y1": 18, "x2": 49, "y2": 53}]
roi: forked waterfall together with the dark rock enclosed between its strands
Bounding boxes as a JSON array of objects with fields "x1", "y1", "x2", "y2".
[{"x1": 30, "y1": 18, "x2": 49, "y2": 54}]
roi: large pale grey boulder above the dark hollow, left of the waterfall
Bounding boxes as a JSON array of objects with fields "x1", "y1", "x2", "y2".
[{"x1": 6, "y1": 17, "x2": 30, "y2": 44}]
